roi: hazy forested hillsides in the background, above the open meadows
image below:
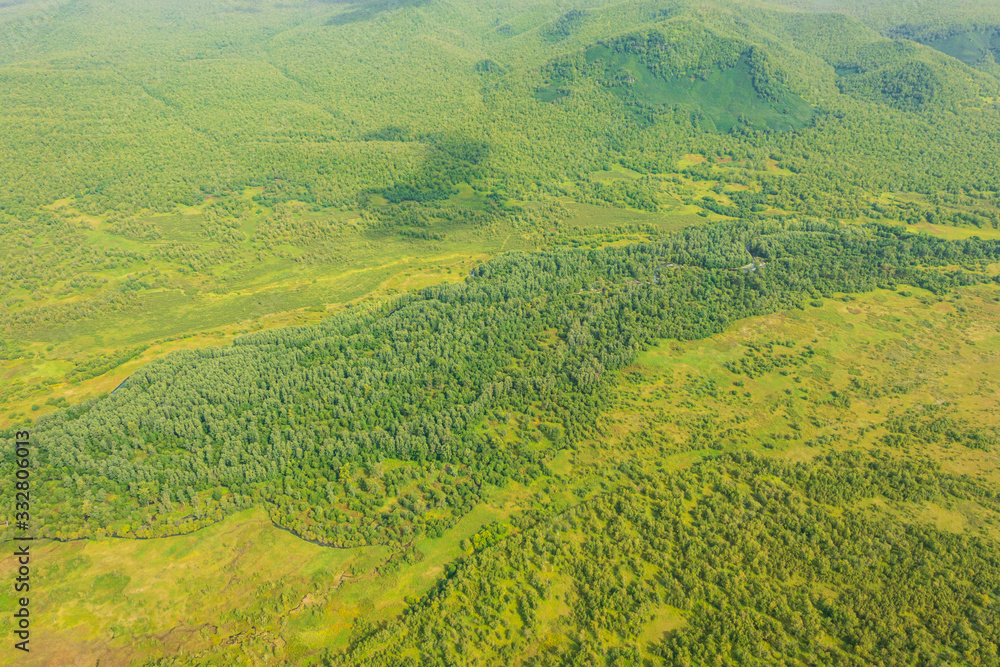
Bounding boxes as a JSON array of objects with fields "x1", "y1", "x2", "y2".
[{"x1": 0, "y1": 0, "x2": 1000, "y2": 214}]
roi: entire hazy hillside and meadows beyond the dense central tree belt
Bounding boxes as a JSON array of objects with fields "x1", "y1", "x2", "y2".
[{"x1": 0, "y1": 0, "x2": 1000, "y2": 425}]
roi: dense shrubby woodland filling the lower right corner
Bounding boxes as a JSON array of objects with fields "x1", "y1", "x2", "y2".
[{"x1": 344, "y1": 454, "x2": 1000, "y2": 665}]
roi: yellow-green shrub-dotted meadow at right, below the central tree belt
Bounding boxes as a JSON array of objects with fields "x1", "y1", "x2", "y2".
[{"x1": 617, "y1": 286, "x2": 1000, "y2": 490}]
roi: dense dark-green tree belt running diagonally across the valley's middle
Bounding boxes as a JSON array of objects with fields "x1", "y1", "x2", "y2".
[{"x1": 15, "y1": 221, "x2": 1000, "y2": 546}]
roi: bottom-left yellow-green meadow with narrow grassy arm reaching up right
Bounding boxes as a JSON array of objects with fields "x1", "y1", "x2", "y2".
[{"x1": 0, "y1": 484, "x2": 572, "y2": 665}]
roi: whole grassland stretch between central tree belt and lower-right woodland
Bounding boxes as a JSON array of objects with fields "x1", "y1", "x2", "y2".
[{"x1": 9, "y1": 286, "x2": 1000, "y2": 665}]
